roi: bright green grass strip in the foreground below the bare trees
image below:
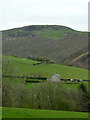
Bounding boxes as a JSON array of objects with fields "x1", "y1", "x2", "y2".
[{"x1": 2, "y1": 107, "x2": 88, "y2": 118}]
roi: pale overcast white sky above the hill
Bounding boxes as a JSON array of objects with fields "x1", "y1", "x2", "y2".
[{"x1": 0, "y1": 0, "x2": 89, "y2": 31}]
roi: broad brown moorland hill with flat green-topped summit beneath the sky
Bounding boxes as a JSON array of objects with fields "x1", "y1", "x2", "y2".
[{"x1": 2, "y1": 25, "x2": 88, "y2": 68}]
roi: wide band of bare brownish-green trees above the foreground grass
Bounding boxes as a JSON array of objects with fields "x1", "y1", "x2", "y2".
[{"x1": 2, "y1": 80, "x2": 87, "y2": 111}]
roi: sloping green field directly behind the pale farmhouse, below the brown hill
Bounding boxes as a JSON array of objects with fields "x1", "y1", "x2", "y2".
[{"x1": 3, "y1": 56, "x2": 88, "y2": 80}]
